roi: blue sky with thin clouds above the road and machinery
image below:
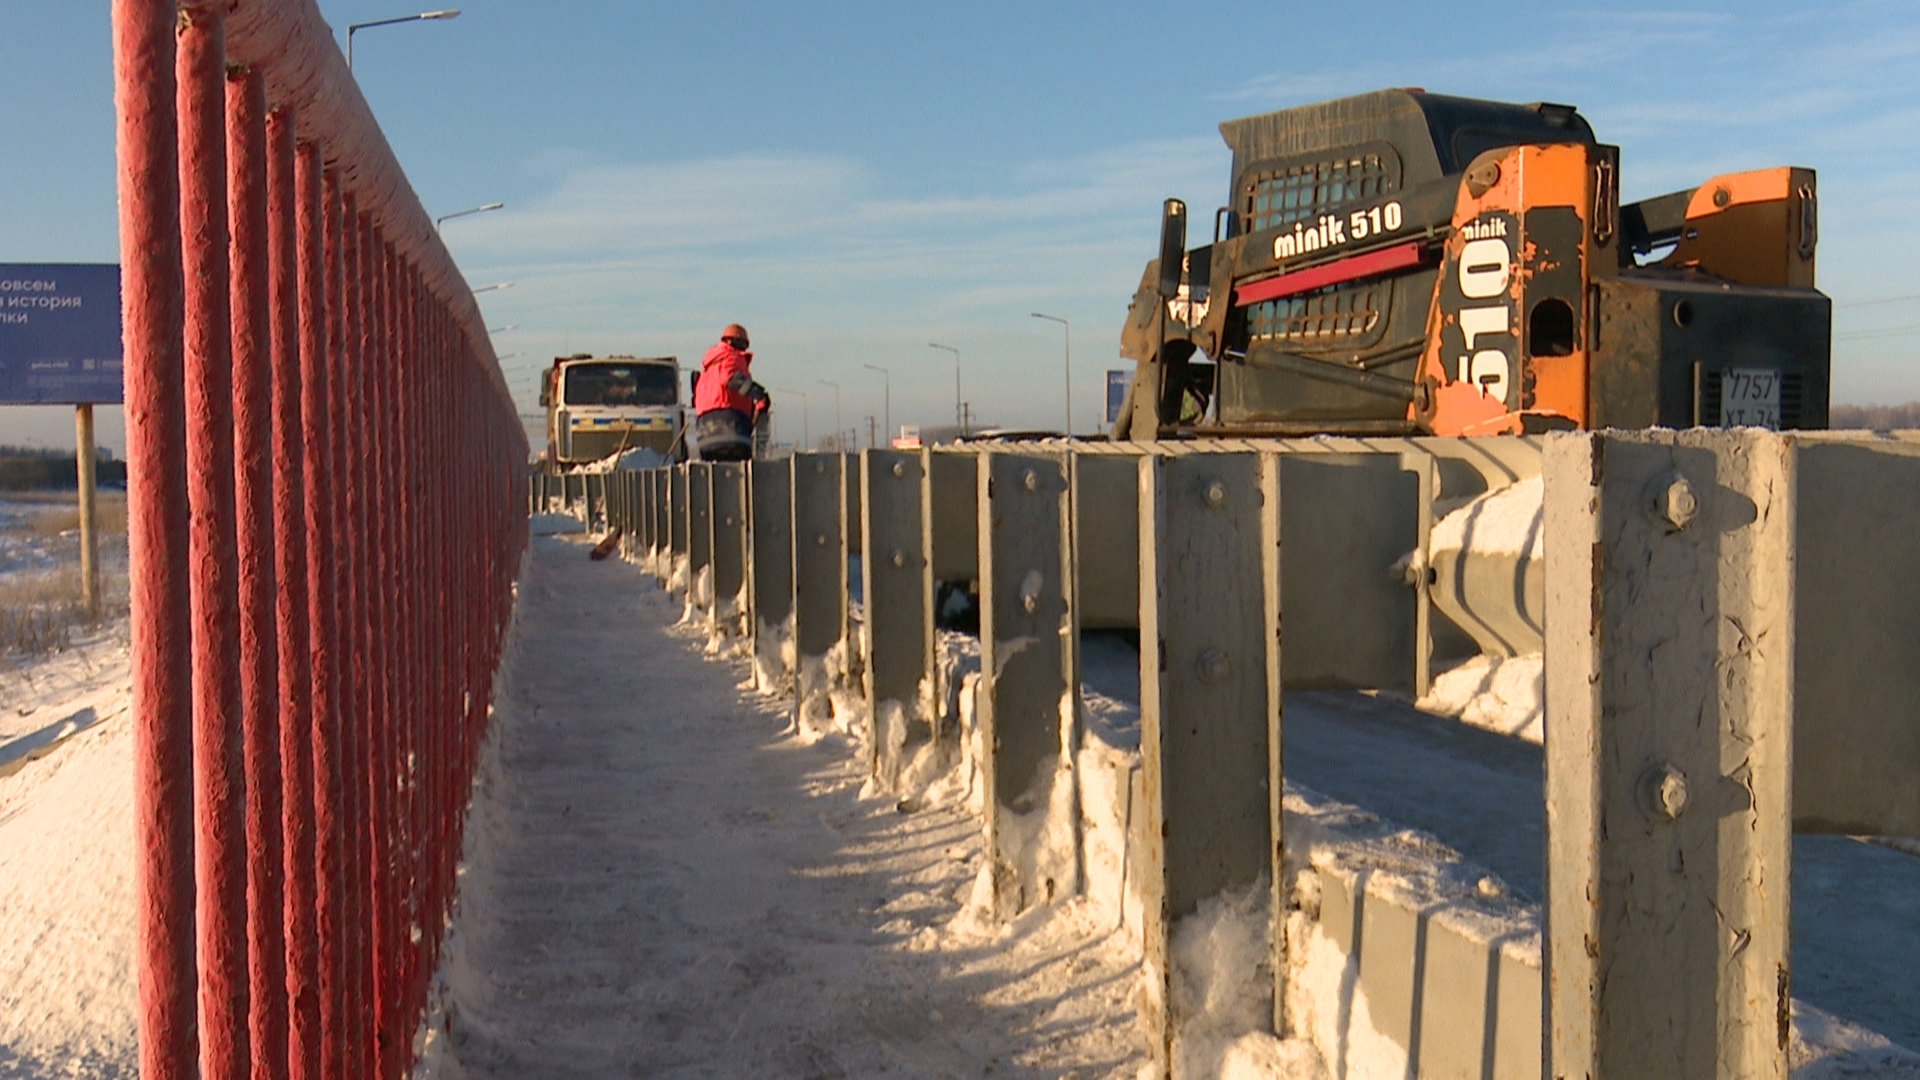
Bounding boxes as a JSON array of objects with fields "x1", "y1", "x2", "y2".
[{"x1": 0, "y1": 0, "x2": 1920, "y2": 446}]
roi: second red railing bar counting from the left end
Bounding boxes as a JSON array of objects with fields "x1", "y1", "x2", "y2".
[{"x1": 177, "y1": 4, "x2": 248, "y2": 1078}]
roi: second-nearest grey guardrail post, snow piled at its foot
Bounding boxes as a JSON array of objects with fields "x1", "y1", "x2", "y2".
[{"x1": 1133, "y1": 454, "x2": 1286, "y2": 1068}]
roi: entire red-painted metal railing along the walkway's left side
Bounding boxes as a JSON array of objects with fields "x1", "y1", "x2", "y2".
[{"x1": 113, "y1": 0, "x2": 526, "y2": 1078}]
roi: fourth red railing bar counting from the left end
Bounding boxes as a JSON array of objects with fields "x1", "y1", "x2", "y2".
[{"x1": 266, "y1": 106, "x2": 324, "y2": 1080}]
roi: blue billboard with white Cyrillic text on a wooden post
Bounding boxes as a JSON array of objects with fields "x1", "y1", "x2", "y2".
[{"x1": 0, "y1": 263, "x2": 123, "y2": 405}]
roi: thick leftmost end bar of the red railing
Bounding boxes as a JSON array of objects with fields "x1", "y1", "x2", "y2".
[{"x1": 113, "y1": 0, "x2": 198, "y2": 1080}]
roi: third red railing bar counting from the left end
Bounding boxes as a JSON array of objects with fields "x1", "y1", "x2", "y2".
[{"x1": 227, "y1": 67, "x2": 286, "y2": 1080}]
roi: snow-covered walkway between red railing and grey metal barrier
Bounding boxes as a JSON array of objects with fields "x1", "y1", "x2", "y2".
[{"x1": 428, "y1": 538, "x2": 1144, "y2": 1078}]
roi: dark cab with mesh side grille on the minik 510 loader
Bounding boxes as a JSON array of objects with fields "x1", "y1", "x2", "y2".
[{"x1": 1205, "y1": 90, "x2": 1594, "y2": 430}]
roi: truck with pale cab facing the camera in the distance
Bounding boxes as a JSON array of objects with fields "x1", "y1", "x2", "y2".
[{"x1": 540, "y1": 354, "x2": 687, "y2": 471}]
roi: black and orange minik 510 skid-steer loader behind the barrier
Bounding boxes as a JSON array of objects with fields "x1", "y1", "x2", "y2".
[{"x1": 1112, "y1": 90, "x2": 1832, "y2": 440}]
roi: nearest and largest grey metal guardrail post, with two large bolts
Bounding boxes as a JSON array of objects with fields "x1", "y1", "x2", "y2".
[{"x1": 1546, "y1": 430, "x2": 1795, "y2": 1080}]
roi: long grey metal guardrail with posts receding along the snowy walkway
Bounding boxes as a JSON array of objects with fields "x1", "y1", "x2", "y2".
[{"x1": 532, "y1": 430, "x2": 1920, "y2": 1078}]
